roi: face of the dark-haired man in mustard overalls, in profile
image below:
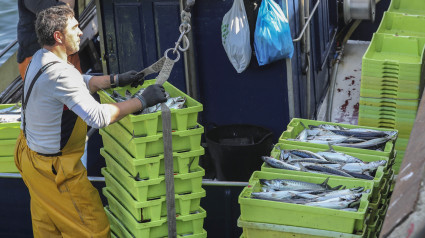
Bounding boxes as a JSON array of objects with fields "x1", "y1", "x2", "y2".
[{"x1": 63, "y1": 17, "x2": 83, "y2": 55}]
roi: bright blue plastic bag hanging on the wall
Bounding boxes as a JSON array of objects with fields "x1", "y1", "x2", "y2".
[{"x1": 254, "y1": 0, "x2": 294, "y2": 65}]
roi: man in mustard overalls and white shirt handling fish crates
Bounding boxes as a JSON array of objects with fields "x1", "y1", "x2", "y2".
[{"x1": 15, "y1": 5, "x2": 166, "y2": 237}]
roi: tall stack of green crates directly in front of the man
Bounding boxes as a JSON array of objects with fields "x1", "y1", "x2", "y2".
[{"x1": 99, "y1": 80, "x2": 207, "y2": 238}]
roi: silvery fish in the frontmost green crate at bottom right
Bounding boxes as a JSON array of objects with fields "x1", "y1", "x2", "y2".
[{"x1": 251, "y1": 178, "x2": 364, "y2": 212}]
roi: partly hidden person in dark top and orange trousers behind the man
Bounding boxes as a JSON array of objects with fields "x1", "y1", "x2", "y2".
[{"x1": 17, "y1": 0, "x2": 81, "y2": 79}]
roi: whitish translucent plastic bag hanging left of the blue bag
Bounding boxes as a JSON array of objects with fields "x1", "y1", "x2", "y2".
[{"x1": 221, "y1": 0, "x2": 252, "y2": 73}]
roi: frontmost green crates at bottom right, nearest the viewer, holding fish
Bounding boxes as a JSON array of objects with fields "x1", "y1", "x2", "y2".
[{"x1": 238, "y1": 171, "x2": 374, "y2": 238}]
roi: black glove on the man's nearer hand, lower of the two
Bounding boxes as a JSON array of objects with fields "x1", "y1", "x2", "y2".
[{"x1": 133, "y1": 84, "x2": 167, "y2": 109}]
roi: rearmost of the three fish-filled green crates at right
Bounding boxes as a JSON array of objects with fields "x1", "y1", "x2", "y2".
[{"x1": 279, "y1": 118, "x2": 394, "y2": 157}]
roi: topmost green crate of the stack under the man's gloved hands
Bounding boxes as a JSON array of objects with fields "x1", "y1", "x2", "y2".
[{"x1": 98, "y1": 80, "x2": 203, "y2": 136}]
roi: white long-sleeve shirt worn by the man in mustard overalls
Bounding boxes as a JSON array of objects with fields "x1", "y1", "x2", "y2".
[{"x1": 21, "y1": 48, "x2": 111, "y2": 154}]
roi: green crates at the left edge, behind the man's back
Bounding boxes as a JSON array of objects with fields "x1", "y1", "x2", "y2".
[{"x1": 0, "y1": 104, "x2": 21, "y2": 173}]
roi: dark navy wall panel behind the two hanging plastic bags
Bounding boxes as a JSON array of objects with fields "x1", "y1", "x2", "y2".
[{"x1": 193, "y1": 0, "x2": 289, "y2": 141}]
